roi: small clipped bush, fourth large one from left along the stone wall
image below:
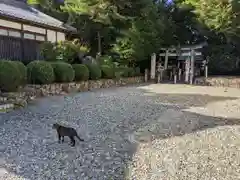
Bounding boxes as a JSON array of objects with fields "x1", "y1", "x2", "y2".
[{"x1": 72, "y1": 64, "x2": 89, "y2": 81}]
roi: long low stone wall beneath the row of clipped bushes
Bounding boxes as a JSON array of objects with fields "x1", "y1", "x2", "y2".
[{"x1": 0, "y1": 76, "x2": 144, "y2": 106}]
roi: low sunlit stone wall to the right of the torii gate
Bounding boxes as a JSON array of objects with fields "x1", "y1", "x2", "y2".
[{"x1": 194, "y1": 76, "x2": 240, "y2": 88}]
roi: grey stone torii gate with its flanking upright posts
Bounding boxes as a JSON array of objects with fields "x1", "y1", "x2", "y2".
[{"x1": 151, "y1": 42, "x2": 207, "y2": 84}]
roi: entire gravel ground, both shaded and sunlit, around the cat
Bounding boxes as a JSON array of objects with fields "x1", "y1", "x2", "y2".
[{"x1": 0, "y1": 85, "x2": 240, "y2": 180}]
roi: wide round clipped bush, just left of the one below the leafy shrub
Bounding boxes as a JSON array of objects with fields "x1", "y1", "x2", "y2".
[{"x1": 27, "y1": 61, "x2": 55, "y2": 84}]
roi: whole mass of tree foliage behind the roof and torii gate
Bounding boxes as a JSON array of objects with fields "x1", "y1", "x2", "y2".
[{"x1": 29, "y1": 0, "x2": 240, "y2": 74}]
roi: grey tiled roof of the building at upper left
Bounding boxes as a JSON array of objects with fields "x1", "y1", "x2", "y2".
[{"x1": 0, "y1": 0, "x2": 75, "y2": 31}]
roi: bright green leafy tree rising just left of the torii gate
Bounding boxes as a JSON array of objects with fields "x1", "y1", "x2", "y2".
[{"x1": 113, "y1": 0, "x2": 167, "y2": 66}]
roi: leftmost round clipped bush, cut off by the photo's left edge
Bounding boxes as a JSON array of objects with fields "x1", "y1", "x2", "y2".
[{"x1": 0, "y1": 60, "x2": 21, "y2": 92}]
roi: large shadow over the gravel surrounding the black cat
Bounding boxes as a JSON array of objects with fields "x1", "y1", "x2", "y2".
[{"x1": 0, "y1": 84, "x2": 240, "y2": 180}]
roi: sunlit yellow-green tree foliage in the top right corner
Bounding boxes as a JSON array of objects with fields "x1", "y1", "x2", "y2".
[{"x1": 183, "y1": 0, "x2": 240, "y2": 37}]
